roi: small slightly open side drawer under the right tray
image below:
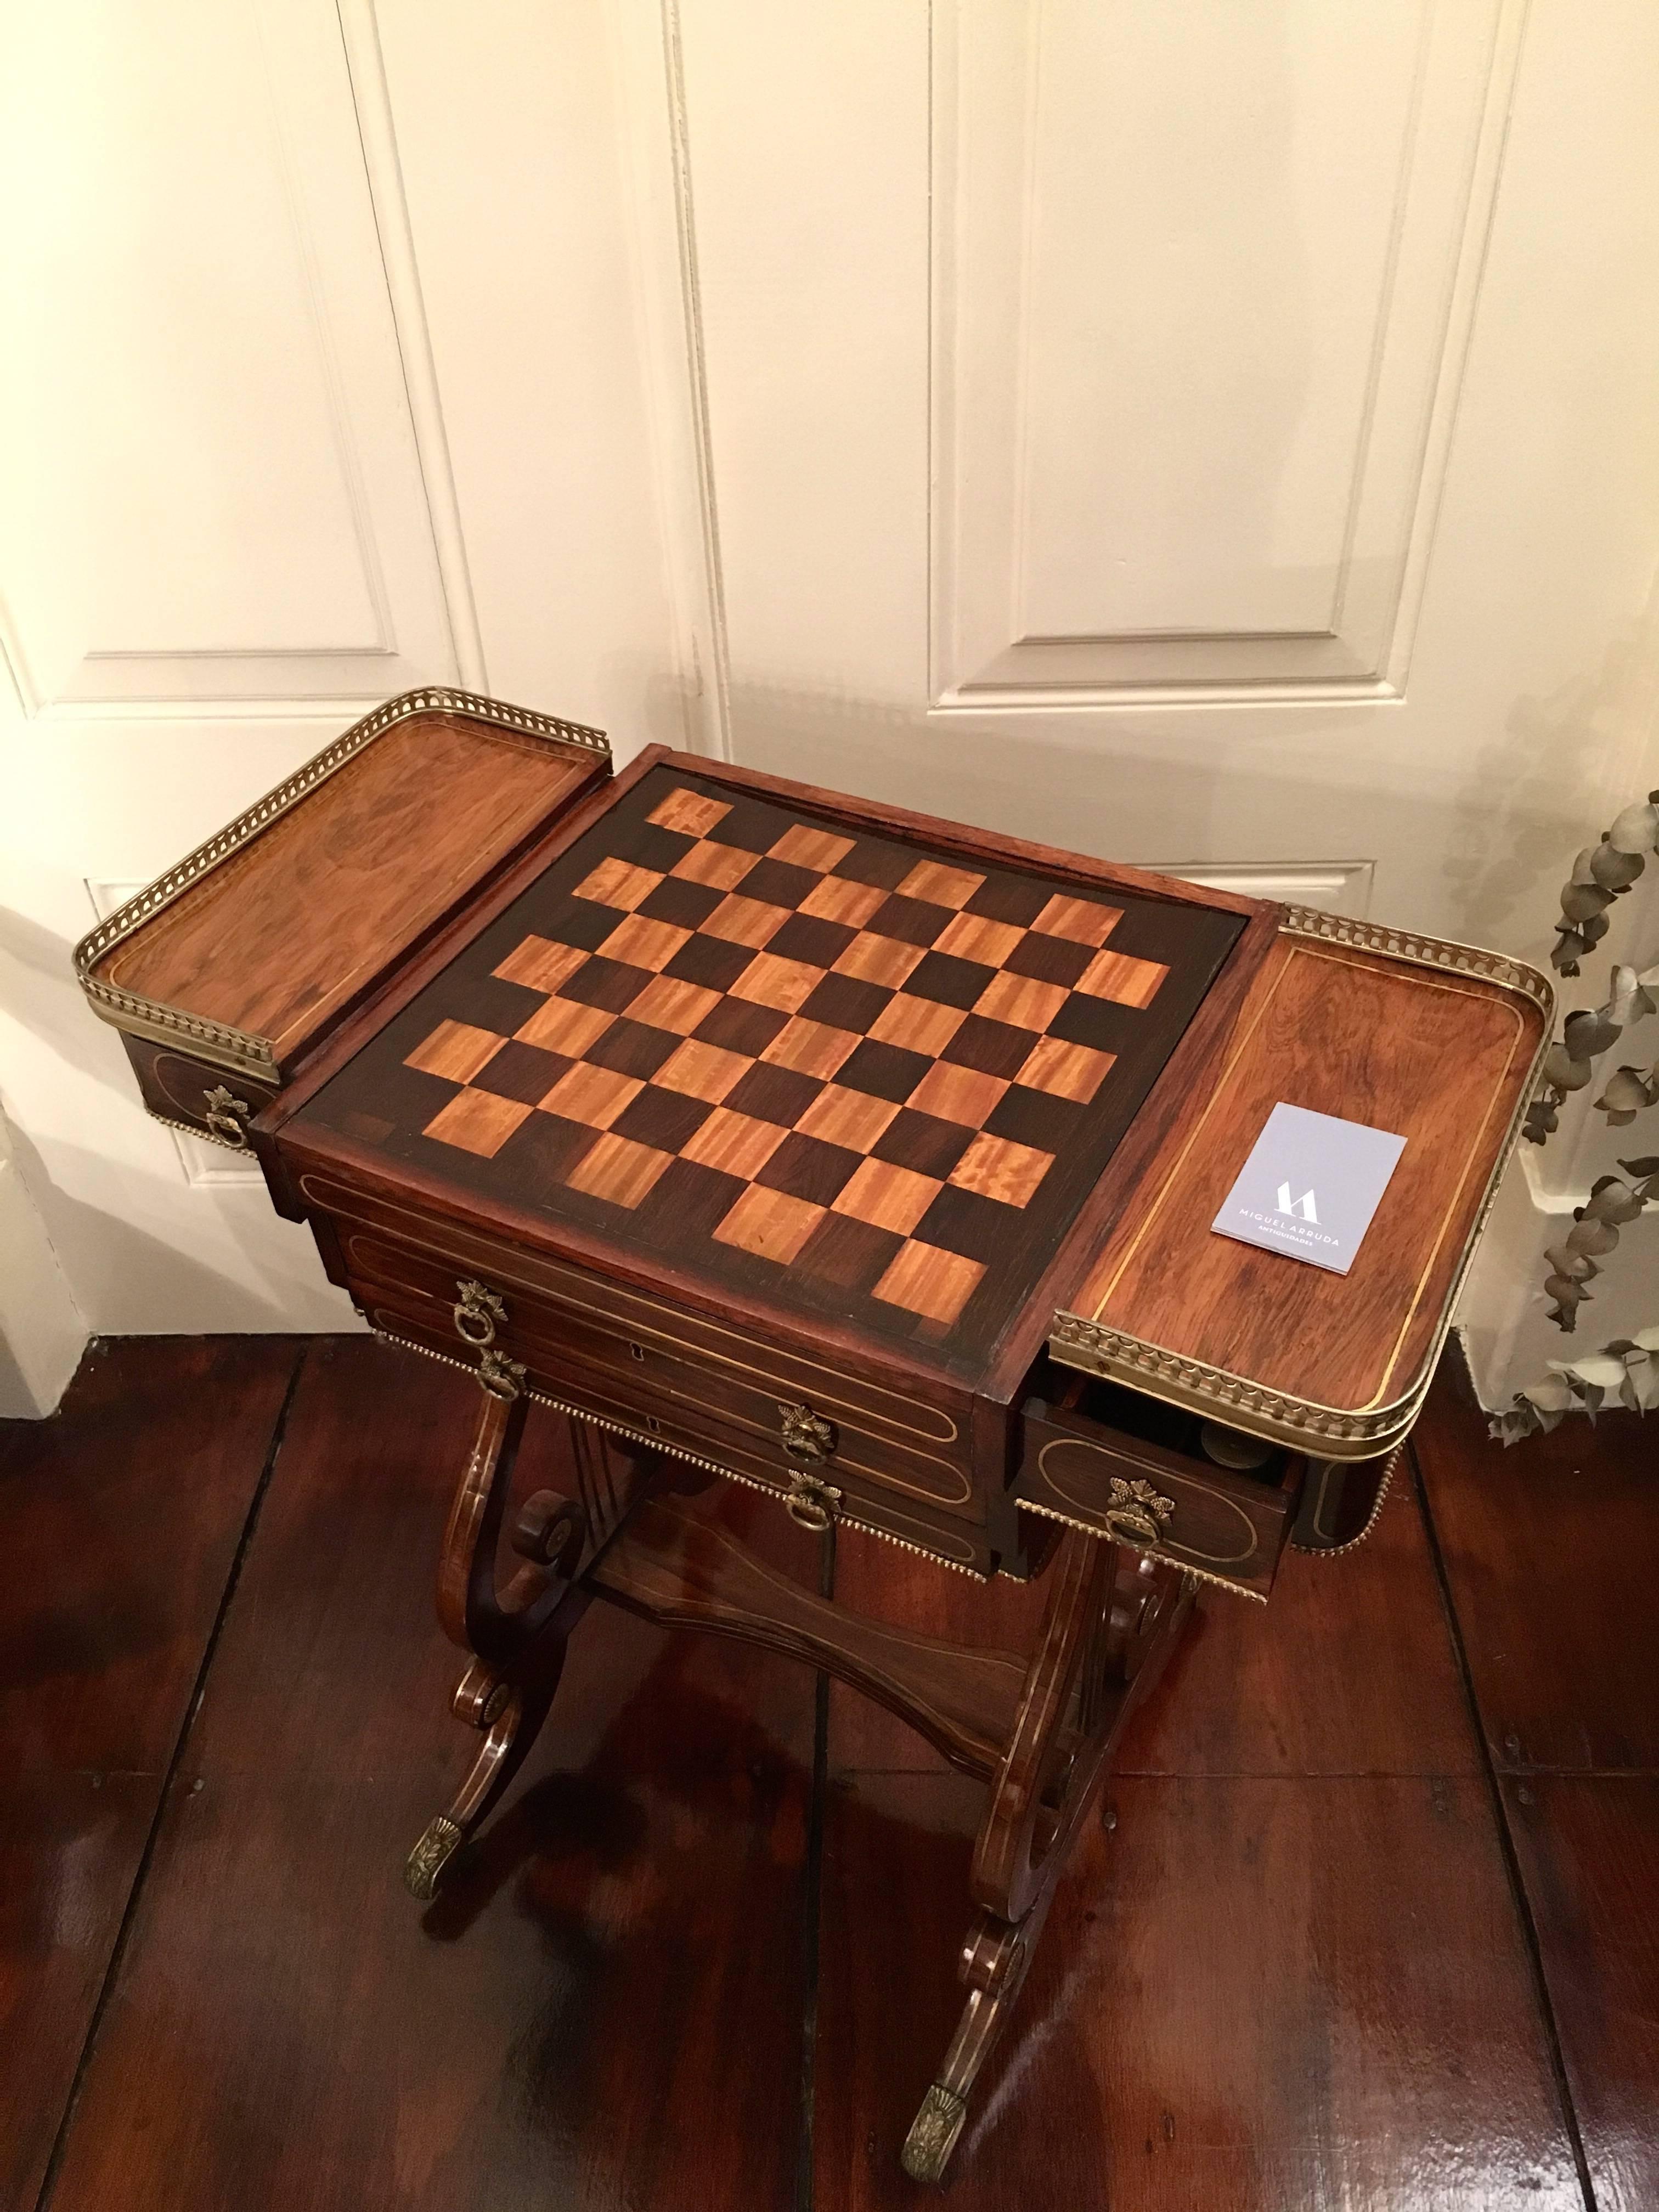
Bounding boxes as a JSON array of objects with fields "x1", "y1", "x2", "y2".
[{"x1": 1013, "y1": 1369, "x2": 1307, "y2": 1599}]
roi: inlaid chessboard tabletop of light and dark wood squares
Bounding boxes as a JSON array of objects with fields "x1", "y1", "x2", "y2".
[{"x1": 305, "y1": 765, "x2": 1241, "y2": 1369}]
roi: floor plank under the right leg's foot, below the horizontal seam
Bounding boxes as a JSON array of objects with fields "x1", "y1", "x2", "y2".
[{"x1": 814, "y1": 1774, "x2": 1584, "y2": 2212}]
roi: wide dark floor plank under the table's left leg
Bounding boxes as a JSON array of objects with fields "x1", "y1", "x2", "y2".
[{"x1": 53, "y1": 1338, "x2": 816, "y2": 2212}]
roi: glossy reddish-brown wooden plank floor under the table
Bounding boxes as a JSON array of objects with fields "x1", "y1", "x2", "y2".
[{"x1": 0, "y1": 1338, "x2": 1659, "y2": 2212}]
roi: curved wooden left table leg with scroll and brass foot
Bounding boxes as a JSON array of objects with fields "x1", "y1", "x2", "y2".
[{"x1": 403, "y1": 1361, "x2": 586, "y2": 1905}]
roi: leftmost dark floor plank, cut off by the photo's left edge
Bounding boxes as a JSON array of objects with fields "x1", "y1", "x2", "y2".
[{"x1": 0, "y1": 1336, "x2": 301, "y2": 2205}]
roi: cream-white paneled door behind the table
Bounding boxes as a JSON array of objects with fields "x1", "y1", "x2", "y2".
[{"x1": 0, "y1": 0, "x2": 1659, "y2": 1407}]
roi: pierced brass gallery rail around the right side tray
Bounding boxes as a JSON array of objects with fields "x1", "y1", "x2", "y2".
[{"x1": 1053, "y1": 907, "x2": 1555, "y2": 1460}]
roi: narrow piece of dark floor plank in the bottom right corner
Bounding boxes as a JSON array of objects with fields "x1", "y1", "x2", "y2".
[{"x1": 1504, "y1": 1774, "x2": 1659, "y2": 2212}]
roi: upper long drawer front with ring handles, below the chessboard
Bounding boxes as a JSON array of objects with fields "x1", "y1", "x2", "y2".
[{"x1": 338, "y1": 1221, "x2": 984, "y2": 1522}]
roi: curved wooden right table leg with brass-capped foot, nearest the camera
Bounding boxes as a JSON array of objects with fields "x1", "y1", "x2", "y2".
[{"x1": 902, "y1": 1531, "x2": 1194, "y2": 2181}]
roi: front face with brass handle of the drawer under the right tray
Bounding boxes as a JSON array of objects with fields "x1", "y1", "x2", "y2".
[{"x1": 1013, "y1": 1400, "x2": 1305, "y2": 1597}]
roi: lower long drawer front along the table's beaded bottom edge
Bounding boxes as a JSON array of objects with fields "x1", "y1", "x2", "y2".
[{"x1": 352, "y1": 1281, "x2": 993, "y2": 1575}]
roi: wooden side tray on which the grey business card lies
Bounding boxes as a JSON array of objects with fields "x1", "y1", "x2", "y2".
[{"x1": 1048, "y1": 907, "x2": 1555, "y2": 1460}]
